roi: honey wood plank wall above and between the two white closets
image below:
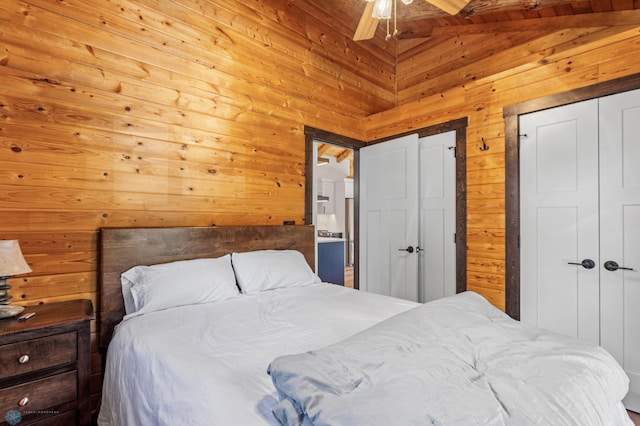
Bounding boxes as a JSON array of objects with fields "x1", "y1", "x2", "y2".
[{"x1": 365, "y1": 26, "x2": 640, "y2": 310}]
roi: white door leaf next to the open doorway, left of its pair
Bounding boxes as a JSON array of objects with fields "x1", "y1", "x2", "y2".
[{"x1": 359, "y1": 134, "x2": 418, "y2": 301}]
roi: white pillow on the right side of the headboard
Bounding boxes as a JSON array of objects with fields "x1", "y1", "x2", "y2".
[{"x1": 231, "y1": 250, "x2": 320, "y2": 294}]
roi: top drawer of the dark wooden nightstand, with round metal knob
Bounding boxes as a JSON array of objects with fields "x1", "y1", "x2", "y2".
[{"x1": 0, "y1": 331, "x2": 78, "y2": 380}]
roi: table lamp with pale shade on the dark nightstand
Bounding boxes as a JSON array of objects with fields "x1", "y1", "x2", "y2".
[{"x1": 0, "y1": 240, "x2": 31, "y2": 318}]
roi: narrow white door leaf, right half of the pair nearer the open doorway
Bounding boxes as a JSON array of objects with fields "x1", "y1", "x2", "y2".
[{"x1": 419, "y1": 131, "x2": 456, "y2": 302}]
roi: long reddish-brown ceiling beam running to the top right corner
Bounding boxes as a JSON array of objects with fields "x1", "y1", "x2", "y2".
[{"x1": 399, "y1": 9, "x2": 640, "y2": 38}]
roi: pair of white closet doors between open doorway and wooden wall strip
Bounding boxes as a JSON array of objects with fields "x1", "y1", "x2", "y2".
[{"x1": 360, "y1": 131, "x2": 456, "y2": 302}]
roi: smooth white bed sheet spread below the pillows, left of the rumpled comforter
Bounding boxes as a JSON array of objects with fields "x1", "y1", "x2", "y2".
[{"x1": 98, "y1": 283, "x2": 417, "y2": 426}]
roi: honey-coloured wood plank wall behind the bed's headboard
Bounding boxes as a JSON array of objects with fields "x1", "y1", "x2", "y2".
[{"x1": 0, "y1": 0, "x2": 395, "y2": 414}]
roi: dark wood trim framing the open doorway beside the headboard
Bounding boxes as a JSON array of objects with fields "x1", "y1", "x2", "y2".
[{"x1": 304, "y1": 126, "x2": 367, "y2": 289}]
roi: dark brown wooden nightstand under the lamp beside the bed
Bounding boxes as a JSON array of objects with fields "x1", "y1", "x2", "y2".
[{"x1": 0, "y1": 300, "x2": 94, "y2": 426}]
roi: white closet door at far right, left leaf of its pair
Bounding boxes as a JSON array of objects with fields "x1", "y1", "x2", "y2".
[{"x1": 520, "y1": 100, "x2": 600, "y2": 345}]
